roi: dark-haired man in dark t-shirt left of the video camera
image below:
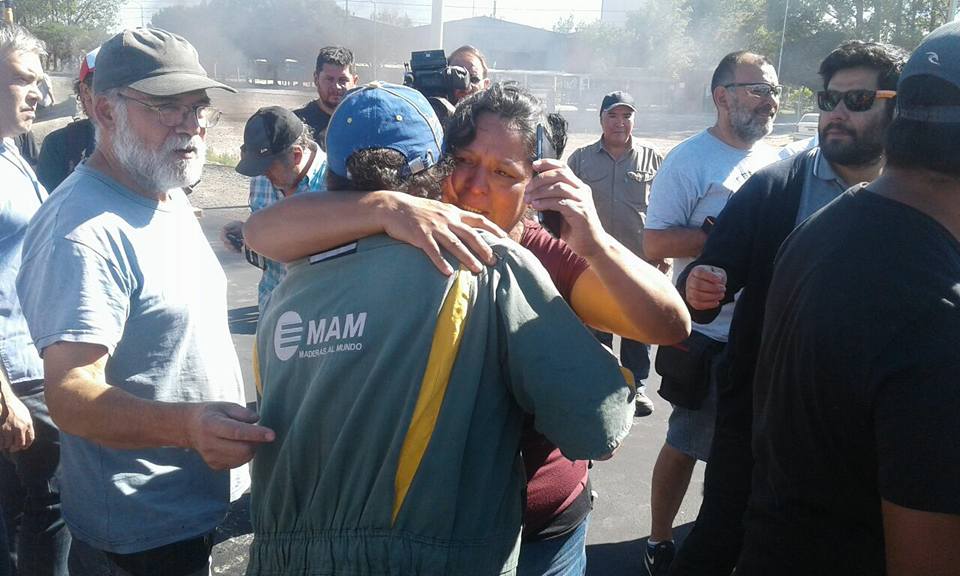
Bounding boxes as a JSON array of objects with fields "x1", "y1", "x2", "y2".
[{"x1": 293, "y1": 46, "x2": 360, "y2": 150}]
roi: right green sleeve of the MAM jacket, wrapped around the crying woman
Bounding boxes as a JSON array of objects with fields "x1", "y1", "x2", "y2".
[{"x1": 496, "y1": 243, "x2": 633, "y2": 460}]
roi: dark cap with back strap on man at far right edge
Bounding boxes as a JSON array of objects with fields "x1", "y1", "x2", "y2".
[{"x1": 897, "y1": 21, "x2": 960, "y2": 124}]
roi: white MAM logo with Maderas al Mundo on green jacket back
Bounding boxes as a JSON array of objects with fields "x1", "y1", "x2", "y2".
[{"x1": 273, "y1": 311, "x2": 367, "y2": 362}]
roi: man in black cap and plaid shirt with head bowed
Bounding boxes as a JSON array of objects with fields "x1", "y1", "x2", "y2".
[{"x1": 221, "y1": 106, "x2": 327, "y2": 309}]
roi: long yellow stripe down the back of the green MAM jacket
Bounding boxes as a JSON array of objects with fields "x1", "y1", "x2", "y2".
[{"x1": 393, "y1": 269, "x2": 477, "y2": 522}]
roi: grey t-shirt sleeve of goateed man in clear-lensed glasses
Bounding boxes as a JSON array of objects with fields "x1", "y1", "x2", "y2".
[{"x1": 644, "y1": 155, "x2": 699, "y2": 230}]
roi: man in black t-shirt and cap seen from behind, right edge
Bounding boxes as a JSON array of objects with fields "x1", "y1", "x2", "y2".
[{"x1": 737, "y1": 22, "x2": 960, "y2": 576}]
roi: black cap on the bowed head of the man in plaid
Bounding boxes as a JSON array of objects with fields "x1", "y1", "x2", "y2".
[{"x1": 236, "y1": 106, "x2": 304, "y2": 178}]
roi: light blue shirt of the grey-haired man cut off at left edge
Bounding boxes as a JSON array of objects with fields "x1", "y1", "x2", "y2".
[{"x1": 0, "y1": 139, "x2": 47, "y2": 391}]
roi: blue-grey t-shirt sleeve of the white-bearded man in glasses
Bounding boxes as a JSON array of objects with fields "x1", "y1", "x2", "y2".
[{"x1": 17, "y1": 238, "x2": 132, "y2": 355}]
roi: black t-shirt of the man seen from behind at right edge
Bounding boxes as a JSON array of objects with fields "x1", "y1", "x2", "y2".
[{"x1": 737, "y1": 189, "x2": 960, "y2": 576}]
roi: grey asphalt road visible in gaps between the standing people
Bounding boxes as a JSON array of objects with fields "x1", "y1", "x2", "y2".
[{"x1": 200, "y1": 207, "x2": 703, "y2": 576}]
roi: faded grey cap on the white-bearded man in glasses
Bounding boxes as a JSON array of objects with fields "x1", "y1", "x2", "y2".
[{"x1": 93, "y1": 28, "x2": 236, "y2": 96}]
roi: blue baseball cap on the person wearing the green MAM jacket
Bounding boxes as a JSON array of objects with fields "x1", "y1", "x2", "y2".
[{"x1": 327, "y1": 82, "x2": 443, "y2": 178}]
